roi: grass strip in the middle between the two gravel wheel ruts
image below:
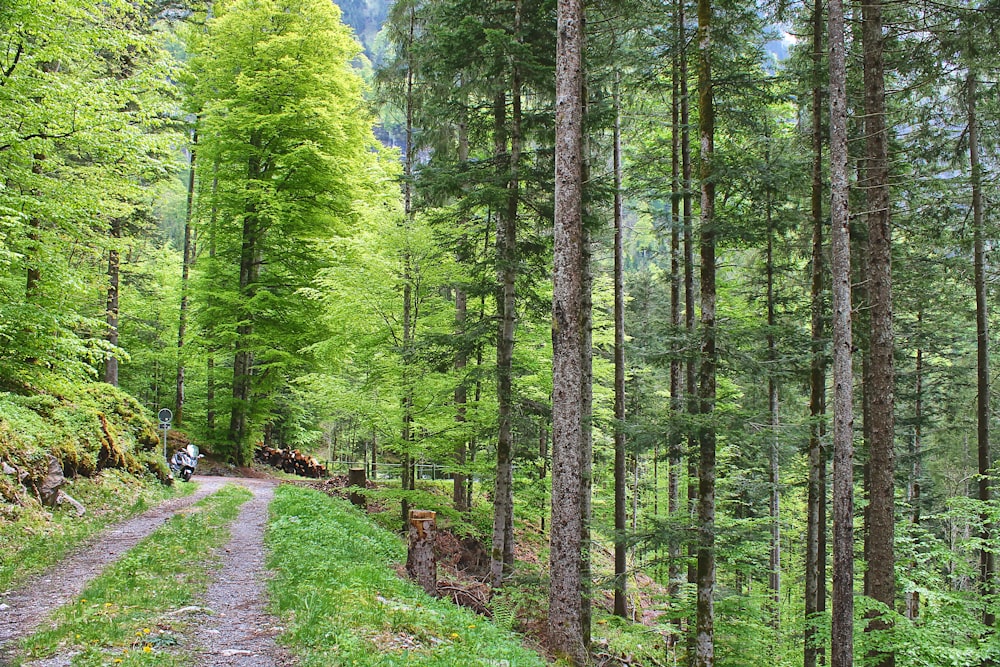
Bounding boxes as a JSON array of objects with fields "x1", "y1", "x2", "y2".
[{"x1": 15, "y1": 486, "x2": 252, "y2": 667}]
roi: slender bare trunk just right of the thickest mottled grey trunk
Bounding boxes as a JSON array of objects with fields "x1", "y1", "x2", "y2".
[{"x1": 612, "y1": 74, "x2": 628, "y2": 618}]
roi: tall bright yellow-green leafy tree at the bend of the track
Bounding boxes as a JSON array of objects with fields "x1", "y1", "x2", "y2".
[{"x1": 191, "y1": 0, "x2": 377, "y2": 464}]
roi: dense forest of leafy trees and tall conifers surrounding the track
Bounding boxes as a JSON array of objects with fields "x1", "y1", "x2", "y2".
[{"x1": 0, "y1": 0, "x2": 1000, "y2": 667}]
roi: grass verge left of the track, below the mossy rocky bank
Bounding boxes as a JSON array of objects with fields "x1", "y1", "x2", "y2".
[{"x1": 0, "y1": 470, "x2": 194, "y2": 591}]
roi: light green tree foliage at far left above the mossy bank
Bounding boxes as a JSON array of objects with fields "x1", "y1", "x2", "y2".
[{"x1": 0, "y1": 0, "x2": 182, "y2": 389}]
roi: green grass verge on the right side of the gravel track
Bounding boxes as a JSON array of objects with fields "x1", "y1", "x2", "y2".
[{"x1": 266, "y1": 486, "x2": 546, "y2": 667}]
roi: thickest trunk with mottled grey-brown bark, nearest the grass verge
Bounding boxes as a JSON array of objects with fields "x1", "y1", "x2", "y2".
[{"x1": 548, "y1": 0, "x2": 589, "y2": 665}]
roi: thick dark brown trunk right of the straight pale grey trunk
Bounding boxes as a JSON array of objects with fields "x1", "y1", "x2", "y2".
[{"x1": 861, "y1": 0, "x2": 896, "y2": 667}]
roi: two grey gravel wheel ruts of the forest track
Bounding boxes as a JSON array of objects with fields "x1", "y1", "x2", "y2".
[{"x1": 0, "y1": 476, "x2": 294, "y2": 667}]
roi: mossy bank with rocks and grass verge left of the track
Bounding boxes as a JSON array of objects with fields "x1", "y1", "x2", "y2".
[{"x1": 0, "y1": 384, "x2": 192, "y2": 592}]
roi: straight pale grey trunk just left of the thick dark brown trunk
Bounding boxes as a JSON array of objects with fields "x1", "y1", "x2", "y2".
[{"x1": 803, "y1": 0, "x2": 826, "y2": 667}]
